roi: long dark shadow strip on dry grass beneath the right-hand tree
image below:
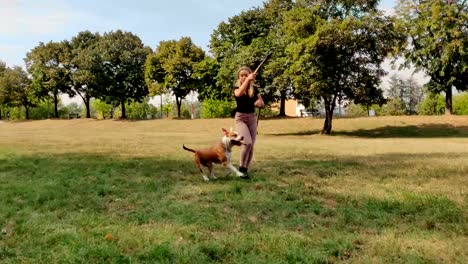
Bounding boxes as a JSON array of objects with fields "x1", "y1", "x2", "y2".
[{"x1": 267, "y1": 124, "x2": 468, "y2": 138}]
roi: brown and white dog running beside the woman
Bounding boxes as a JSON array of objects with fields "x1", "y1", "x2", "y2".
[{"x1": 182, "y1": 128, "x2": 244, "y2": 181}]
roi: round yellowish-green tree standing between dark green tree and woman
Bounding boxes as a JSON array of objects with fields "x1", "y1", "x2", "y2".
[{"x1": 145, "y1": 37, "x2": 205, "y2": 117}]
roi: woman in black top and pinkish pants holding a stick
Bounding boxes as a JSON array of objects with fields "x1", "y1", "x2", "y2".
[{"x1": 234, "y1": 66, "x2": 265, "y2": 179}]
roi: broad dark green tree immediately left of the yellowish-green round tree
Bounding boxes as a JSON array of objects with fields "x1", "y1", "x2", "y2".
[{"x1": 96, "y1": 30, "x2": 151, "y2": 118}]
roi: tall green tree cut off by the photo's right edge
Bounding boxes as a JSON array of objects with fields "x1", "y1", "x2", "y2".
[{"x1": 396, "y1": 0, "x2": 468, "y2": 115}]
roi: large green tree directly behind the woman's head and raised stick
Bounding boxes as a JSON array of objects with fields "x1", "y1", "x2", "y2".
[{"x1": 210, "y1": 0, "x2": 294, "y2": 115}]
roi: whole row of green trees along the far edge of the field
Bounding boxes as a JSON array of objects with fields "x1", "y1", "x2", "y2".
[{"x1": 0, "y1": 0, "x2": 468, "y2": 134}]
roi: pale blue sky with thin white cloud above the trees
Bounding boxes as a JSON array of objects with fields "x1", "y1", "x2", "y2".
[{"x1": 0, "y1": 0, "x2": 396, "y2": 67}]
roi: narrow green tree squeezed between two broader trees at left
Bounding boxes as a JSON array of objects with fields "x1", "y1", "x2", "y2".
[{"x1": 70, "y1": 31, "x2": 105, "y2": 118}]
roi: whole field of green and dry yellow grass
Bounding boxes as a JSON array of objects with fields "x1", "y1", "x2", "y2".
[{"x1": 0, "y1": 116, "x2": 468, "y2": 263}]
